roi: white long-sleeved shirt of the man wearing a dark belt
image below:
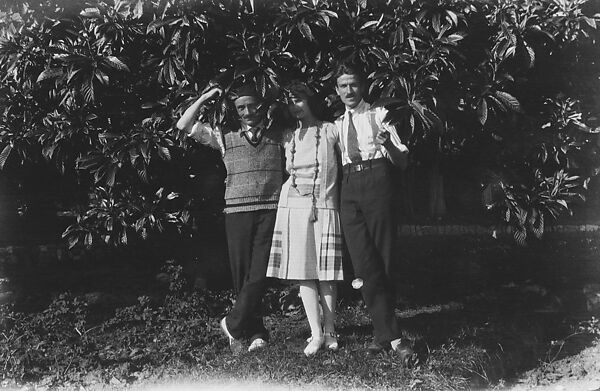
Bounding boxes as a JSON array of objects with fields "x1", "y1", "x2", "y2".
[{"x1": 335, "y1": 100, "x2": 408, "y2": 164}]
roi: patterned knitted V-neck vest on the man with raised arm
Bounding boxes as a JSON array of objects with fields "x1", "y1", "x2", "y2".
[{"x1": 223, "y1": 130, "x2": 283, "y2": 213}]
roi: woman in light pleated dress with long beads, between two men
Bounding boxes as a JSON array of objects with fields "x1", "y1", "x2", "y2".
[{"x1": 267, "y1": 84, "x2": 343, "y2": 356}]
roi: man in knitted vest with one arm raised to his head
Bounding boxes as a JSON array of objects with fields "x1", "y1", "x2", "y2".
[{"x1": 177, "y1": 85, "x2": 283, "y2": 354}]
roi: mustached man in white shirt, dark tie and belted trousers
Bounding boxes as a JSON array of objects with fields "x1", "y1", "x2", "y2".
[{"x1": 335, "y1": 64, "x2": 414, "y2": 360}]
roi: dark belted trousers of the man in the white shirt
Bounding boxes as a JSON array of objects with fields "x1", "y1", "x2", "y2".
[{"x1": 340, "y1": 164, "x2": 400, "y2": 344}]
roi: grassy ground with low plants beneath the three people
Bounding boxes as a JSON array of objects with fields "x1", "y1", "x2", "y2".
[{"x1": 0, "y1": 235, "x2": 600, "y2": 390}]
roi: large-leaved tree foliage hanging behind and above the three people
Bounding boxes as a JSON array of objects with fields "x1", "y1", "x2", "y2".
[{"x1": 0, "y1": 0, "x2": 600, "y2": 246}]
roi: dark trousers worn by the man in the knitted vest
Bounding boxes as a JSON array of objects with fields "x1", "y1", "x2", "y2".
[{"x1": 225, "y1": 209, "x2": 277, "y2": 340}]
